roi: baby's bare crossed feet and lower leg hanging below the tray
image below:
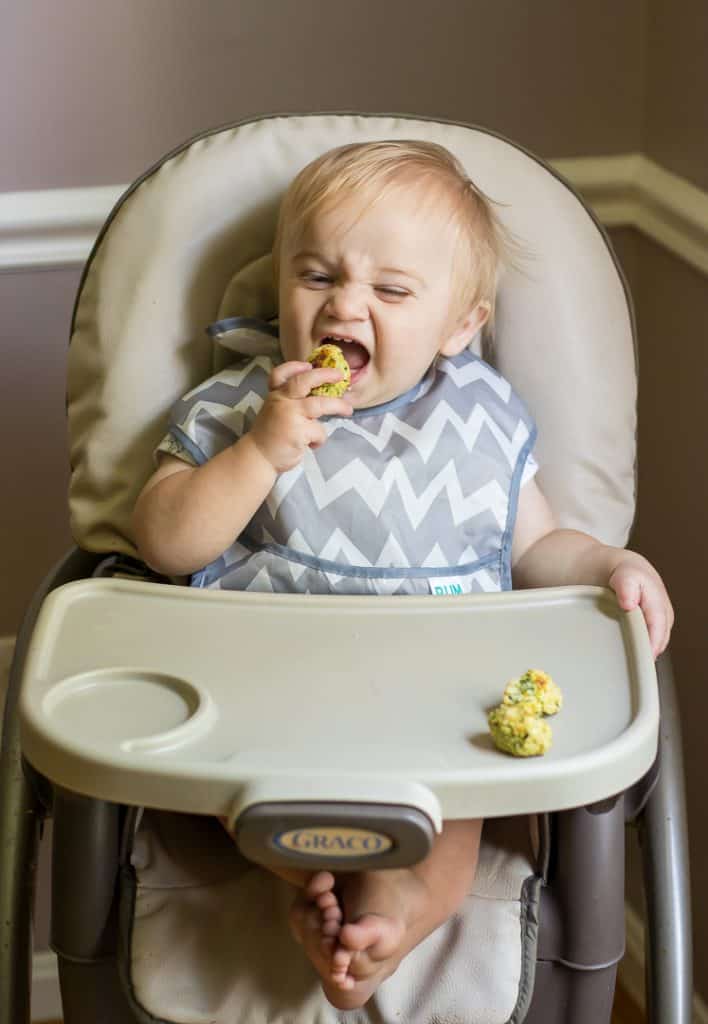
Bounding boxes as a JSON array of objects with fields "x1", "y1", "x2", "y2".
[{"x1": 292, "y1": 820, "x2": 482, "y2": 1010}]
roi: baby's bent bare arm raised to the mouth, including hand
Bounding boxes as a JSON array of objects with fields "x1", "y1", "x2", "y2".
[{"x1": 133, "y1": 362, "x2": 351, "y2": 575}]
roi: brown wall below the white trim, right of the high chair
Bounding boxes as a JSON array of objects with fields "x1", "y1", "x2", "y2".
[{"x1": 635, "y1": 238, "x2": 708, "y2": 974}]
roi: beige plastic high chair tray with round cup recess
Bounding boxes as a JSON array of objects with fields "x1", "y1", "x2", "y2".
[{"x1": 20, "y1": 580, "x2": 659, "y2": 827}]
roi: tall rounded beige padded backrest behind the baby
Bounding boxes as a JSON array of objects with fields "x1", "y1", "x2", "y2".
[{"x1": 69, "y1": 114, "x2": 636, "y2": 554}]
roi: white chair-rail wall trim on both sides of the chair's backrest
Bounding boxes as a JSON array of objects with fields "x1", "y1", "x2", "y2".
[{"x1": 0, "y1": 153, "x2": 708, "y2": 273}]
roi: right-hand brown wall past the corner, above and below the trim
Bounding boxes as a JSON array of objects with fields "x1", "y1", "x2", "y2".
[{"x1": 632, "y1": 0, "x2": 708, "y2": 999}]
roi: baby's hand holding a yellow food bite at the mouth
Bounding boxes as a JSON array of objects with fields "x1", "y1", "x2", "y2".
[{"x1": 248, "y1": 361, "x2": 352, "y2": 473}]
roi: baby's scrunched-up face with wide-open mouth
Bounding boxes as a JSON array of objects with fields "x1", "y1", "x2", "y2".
[{"x1": 280, "y1": 188, "x2": 473, "y2": 409}]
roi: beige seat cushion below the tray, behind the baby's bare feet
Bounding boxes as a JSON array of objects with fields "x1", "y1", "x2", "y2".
[{"x1": 122, "y1": 812, "x2": 538, "y2": 1024}]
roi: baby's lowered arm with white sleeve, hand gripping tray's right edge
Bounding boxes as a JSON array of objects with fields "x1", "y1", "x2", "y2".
[{"x1": 511, "y1": 480, "x2": 673, "y2": 657}]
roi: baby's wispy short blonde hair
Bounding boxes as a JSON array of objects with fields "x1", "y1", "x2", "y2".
[{"x1": 273, "y1": 140, "x2": 512, "y2": 321}]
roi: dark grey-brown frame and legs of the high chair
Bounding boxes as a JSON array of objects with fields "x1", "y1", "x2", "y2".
[{"x1": 0, "y1": 116, "x2": 692, "y2": 1024}]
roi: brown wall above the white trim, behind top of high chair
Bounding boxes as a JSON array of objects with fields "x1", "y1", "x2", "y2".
[{"x1": 0, "y1": 0, "x2": 644, "y2": 191}]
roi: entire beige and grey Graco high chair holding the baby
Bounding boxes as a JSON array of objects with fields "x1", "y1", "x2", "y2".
[{"x1": 0, "y1": 114, "x2": 692, "y2": 1024}]
